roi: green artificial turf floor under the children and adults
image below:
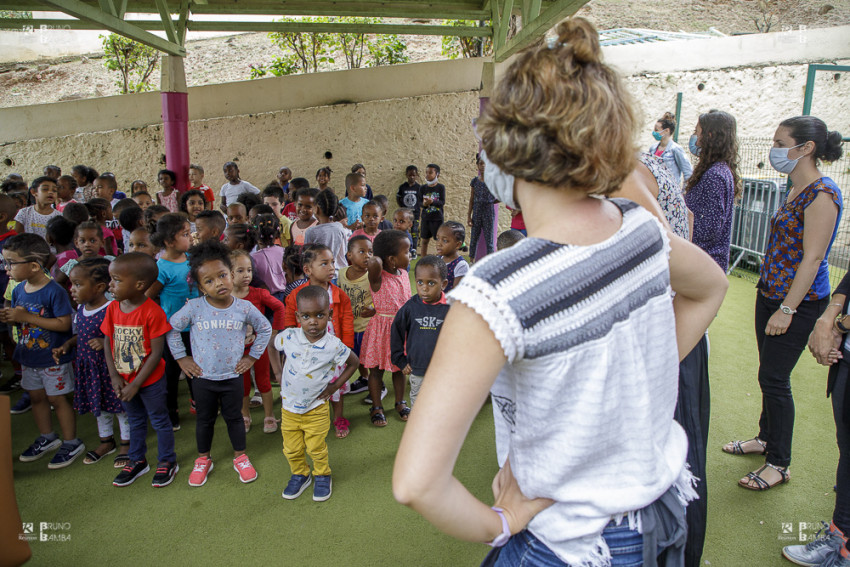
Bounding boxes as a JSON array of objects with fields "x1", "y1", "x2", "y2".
[{"x1": 4, "y1": 277, "x2": 838, "y2": 567}]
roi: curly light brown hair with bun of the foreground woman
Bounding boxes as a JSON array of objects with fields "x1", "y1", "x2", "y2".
[{"x1": 477, "y1": 18, "x2": 637, "y2": 195}]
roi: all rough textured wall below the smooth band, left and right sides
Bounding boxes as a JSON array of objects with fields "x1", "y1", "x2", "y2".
[{"x1": 0, "y1": 61, "x2": 850, "y2": 247}]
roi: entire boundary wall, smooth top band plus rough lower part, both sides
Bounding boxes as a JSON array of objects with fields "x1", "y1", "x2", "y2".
[{"x1": 0, "y1": 28, "x2": 850, "y2": 244}]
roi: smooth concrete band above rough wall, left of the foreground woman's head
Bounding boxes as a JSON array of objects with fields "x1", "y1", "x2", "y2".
[{"x1": 0, "y1": 59, "x2": 484, "y2": 142}]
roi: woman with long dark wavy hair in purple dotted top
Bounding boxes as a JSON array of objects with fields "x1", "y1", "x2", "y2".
[{"x1": 684, "y1": 110, "x2": 741, "y2": 271}]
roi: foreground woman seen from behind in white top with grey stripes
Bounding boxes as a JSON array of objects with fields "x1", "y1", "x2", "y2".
[{"x1": 394, "y1": 18, "x2": 728, "y2": 566}]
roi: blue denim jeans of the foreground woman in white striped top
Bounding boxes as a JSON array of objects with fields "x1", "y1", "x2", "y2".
[{"x1": 482, "y1": 520, "x2": 643, "y2": 567}]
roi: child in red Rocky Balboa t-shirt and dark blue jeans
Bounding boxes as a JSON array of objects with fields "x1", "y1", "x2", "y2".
[{"x1": 100, "y1": 252, "x2": 179, "y2": 487}]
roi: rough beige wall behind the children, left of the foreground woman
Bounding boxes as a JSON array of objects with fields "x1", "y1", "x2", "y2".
[{"x1": 0, "y1": 92, "x2": 510, "y2": 234}]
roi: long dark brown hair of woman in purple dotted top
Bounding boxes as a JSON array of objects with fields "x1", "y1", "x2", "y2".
[{"x1": 685, "y1": 109, "x2": 743, "y2": 199}]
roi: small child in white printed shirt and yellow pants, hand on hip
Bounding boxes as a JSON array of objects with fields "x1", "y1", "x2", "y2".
[{"x1": 274, "y1": 286, "x2": 360, "y2": 502}]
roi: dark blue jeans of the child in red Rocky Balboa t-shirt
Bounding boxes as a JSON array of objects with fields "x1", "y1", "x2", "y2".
[{"x1": 121, "y1": 377, "x2": 177, "y2": 463}]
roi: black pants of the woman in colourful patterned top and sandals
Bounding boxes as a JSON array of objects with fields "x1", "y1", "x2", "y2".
[{"x1": 755, "y1": 293, "x2": 829, "y2": 467}]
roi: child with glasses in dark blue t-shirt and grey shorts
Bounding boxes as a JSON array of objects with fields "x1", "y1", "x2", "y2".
[{"x1": 0, "y1": 234, "x2": 86, "y2": 469}]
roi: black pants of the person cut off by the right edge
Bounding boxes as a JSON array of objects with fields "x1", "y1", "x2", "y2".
[{"x1": 832, "y1": 360, "x2": 850, "y2": 550}]
